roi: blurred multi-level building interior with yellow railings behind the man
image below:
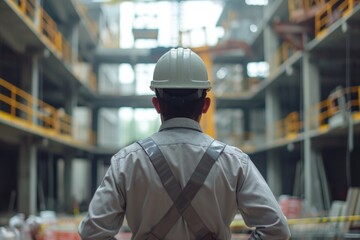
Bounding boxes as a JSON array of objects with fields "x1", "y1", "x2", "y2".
[{"x1": 0, "y1": 0, "x2": 360, "y2": 239}]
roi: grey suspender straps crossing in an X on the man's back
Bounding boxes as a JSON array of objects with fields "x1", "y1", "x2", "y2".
[{"x1": 138, "y1": 138, "x2": 225, "y2": 240}]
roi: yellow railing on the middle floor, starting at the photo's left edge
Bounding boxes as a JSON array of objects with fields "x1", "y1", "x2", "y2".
[{"x1": 0, "y1": 78, "x2": 95, "y2": 144}]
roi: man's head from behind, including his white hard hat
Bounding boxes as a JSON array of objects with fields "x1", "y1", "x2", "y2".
[{"x1": 150, "y1": 48, "x2": 211, "y2": 120}]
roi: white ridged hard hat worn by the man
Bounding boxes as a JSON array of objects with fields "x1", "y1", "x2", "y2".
[{"x1": 150, "y1": 48, "x2": 211, "y2": 91}]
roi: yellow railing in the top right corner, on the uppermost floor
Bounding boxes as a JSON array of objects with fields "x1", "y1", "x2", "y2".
[{"x1": 315, "y1": 0, "x2": 360, "y2": 37}]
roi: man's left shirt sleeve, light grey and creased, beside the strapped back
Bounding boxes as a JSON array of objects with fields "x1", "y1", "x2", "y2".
[{"x1": 78, "y1": 158, "x2": 125, "y2": 240}]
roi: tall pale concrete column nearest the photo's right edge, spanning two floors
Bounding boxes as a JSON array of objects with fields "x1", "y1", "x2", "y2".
[{"x1": 302, "y1": 52, "x2": 320, "y2": 211}]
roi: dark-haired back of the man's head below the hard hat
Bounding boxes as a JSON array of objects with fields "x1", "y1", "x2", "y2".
[{"x1": 156, "y1": 89, "x2": 206, "y2": 120}]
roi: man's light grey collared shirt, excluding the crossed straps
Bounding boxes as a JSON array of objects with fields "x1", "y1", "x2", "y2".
[{"x1": 79, "y1": 118, "x2": 290, "y2": 240}]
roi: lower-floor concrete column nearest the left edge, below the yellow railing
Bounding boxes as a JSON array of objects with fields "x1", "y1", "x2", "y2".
[{"x1": 17, "y1": 137, "x2": 37, "y2": 214}]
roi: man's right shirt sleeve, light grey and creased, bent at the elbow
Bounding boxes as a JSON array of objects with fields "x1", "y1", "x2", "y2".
[{"x1": 237, "y1": 155, "x2": 290, "y2": 240}]
